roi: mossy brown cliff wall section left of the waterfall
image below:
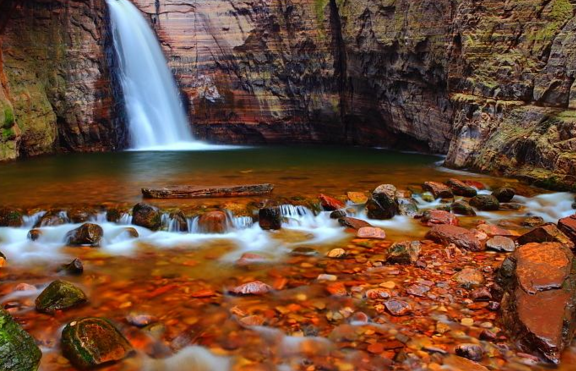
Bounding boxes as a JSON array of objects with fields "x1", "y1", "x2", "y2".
[{"x1": 0, "y1": 0, "x2": 122, "y2": 159}]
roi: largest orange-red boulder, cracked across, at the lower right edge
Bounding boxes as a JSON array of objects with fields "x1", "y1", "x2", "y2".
[{"x1": 497, "y1": 242, "x2": 576, "y2": 363}]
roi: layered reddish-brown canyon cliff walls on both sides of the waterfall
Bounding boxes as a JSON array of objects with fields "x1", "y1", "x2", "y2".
[{"x1": 0, "y1": 0, "x2": 576, "y2": 188}]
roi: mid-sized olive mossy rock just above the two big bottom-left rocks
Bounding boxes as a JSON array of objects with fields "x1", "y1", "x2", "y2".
[{"x1": 36, "y1": 280, "x2": 88, "y2": 313}]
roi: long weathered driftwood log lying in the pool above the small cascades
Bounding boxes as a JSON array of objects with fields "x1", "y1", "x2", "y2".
[{"x1": 142, "y1": 183, "x2": 274, "y2": 198}]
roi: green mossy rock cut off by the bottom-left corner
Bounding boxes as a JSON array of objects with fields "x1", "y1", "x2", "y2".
[{"x1": 0, "y1": 309, "x2": 42, "y2": 371}]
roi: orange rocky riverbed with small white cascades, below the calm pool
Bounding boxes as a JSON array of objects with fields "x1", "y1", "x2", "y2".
[{"x1": 0, "y1": 179, "x2": 576, "y2": 370}]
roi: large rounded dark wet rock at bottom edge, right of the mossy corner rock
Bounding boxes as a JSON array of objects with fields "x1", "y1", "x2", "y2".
[{"x1": 61, "y1": 317, "x2": 133, "y2": 369}]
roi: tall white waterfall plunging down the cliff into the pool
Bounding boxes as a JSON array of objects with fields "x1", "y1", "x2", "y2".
[{"x1": 106, "y1": 0, "x2": 193, "y2": 149}]
